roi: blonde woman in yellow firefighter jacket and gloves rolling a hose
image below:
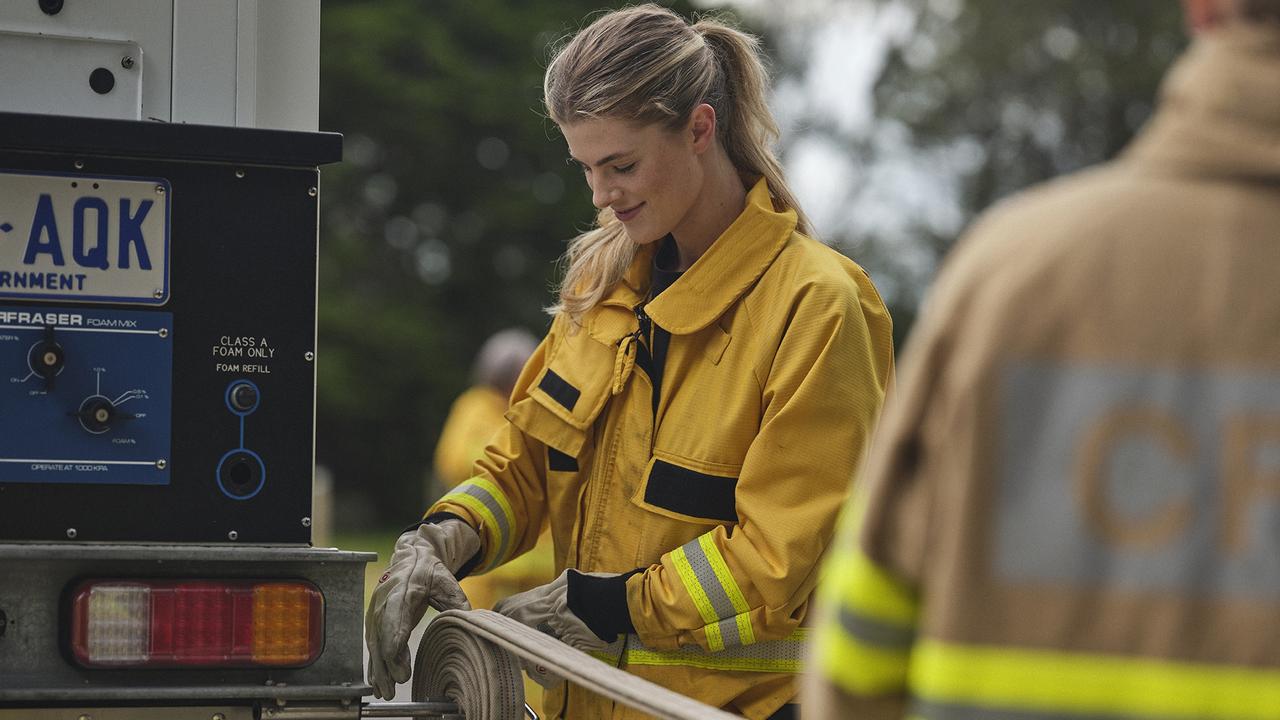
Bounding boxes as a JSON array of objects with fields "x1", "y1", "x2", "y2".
[{"x1": 366, "y1": 5, "x2": 893, "y2": 720}]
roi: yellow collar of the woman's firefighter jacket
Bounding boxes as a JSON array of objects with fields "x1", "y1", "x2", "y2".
[{"x1": 627, "y1": 178, "x2": 796, "y2": 334}]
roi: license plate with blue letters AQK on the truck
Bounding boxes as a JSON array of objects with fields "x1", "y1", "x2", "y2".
[{"x1": 0, "y1": 172, "x2": 170, "y2": 305}]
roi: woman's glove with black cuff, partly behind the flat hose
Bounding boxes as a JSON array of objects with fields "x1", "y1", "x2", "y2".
[{"x1": 493, "y1": 570, "x2": 639, "y2": 687}]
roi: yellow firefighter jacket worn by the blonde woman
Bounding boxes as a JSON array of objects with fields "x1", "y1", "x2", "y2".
[{"x1": 429, "y1": 181, "x2": 893, "y2": 720}]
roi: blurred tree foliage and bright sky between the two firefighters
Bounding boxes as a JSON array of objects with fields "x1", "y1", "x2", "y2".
[{"x1": 758, "y1": 0, "x2": 1187, "y2": 342}]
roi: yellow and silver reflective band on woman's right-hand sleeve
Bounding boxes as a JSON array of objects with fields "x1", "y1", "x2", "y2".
[{"x1": 671, "y1": 533, "x2": 755, "y2": 651}]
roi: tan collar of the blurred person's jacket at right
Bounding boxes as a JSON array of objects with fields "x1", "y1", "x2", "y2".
[{"x1": 1125, "y1": 24, "x2": 1280, "y2": 179}]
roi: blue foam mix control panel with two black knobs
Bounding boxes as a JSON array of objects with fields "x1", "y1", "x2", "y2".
[{"x1": 0, "y1": 305, "x2": 173, "y2": 486}]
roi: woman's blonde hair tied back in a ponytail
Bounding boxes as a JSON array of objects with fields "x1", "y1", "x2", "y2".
[{"x1": 543, "y1": 4, "x2": 810, "y2": 322}]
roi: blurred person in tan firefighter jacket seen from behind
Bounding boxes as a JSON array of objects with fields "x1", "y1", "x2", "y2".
[{"x1": 804, "y1": 0, "x2": 1280, "y2": 720}]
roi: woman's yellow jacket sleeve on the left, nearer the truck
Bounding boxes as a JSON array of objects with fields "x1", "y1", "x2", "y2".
[{"x1": 426, "y1": 320, "x2": 559, "y2": 573}]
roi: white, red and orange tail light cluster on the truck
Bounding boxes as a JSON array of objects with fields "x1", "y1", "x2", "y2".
[{"x1": 70, "y1": 580, "x2": 324, "y2": 667}]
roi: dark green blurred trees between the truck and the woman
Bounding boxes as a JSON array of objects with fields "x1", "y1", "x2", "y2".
[{"x1": 316, "y1": 0, "x2": 690, "y2": 528}]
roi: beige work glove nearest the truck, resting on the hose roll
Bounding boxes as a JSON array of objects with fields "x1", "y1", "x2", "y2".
[{"x1": 365, "y1": 520, "x2": 480, "y2": 700}]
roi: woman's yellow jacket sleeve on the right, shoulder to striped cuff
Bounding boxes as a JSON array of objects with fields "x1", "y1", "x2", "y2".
[{"x1": 627, "y1": 270, "x2": 892, "y2": 651}]
